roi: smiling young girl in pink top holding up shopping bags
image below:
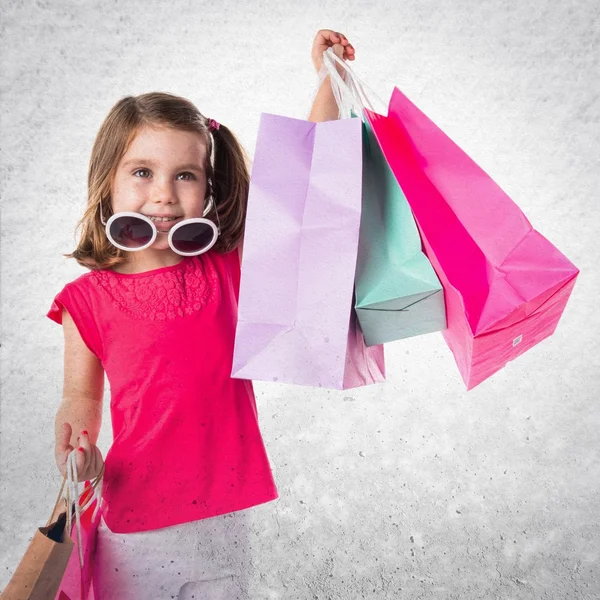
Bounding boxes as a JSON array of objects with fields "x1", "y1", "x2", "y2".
[{"x1": 48, "y1": 29, "x2": 354, "y2": 600}]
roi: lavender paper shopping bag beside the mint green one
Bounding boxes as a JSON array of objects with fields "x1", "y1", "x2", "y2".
[{"x1": 231, "y1": 114, "x2": 385, "y2": 389}]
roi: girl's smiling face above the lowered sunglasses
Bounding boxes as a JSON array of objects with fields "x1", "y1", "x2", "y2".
[{"x1": 111, "y1": 125, "x2": 207, "y2": 252}]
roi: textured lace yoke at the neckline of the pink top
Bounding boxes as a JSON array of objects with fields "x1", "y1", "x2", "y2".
[{"x1": 90, "y1": 257, "x2": 219, "y2": 321}]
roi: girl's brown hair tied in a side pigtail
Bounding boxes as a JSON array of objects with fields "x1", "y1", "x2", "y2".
[{"x1": 65, "y1": 92, "x2": 250, "y2": 269}]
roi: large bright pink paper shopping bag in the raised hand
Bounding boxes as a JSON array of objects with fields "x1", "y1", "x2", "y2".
[{"x1": 365, "y1": 88, "x2": 579, "y2": 389}]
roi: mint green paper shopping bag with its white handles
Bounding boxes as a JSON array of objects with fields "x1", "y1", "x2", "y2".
[{"x1": 323, "y1": 49, "x2": 446, "y2": 346}]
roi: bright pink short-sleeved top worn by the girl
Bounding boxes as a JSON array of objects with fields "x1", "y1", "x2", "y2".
[{"x1": 48, "y1": 250, "x2": 278, "y2": 533}]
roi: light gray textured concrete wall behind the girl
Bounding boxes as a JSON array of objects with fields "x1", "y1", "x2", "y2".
[{"x1": 0, "y1": 0, "x2": 600, "y2": 600}]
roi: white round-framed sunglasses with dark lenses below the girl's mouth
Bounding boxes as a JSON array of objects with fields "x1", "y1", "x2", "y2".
[{"x1": 100, "y1": 207, "x2": 221, "y2": 256}]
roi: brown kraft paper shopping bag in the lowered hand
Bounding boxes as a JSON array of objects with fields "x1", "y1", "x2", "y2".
[{"x1": 0, "y1": 492, "x2": 74, "y2": 600}]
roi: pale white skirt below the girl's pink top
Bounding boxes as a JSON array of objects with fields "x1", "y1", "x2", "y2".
[{"x1": 94, "y1": 510, "x2": 251, "y2": 600}]
